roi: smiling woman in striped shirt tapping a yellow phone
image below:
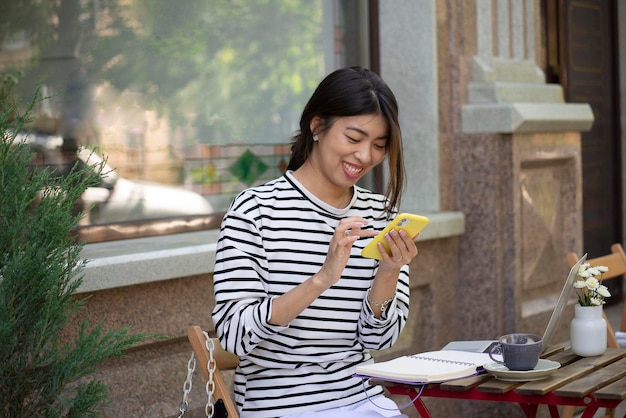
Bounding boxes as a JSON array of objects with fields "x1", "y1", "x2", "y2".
[{"x1": 213, "y1": 67, "x2": 417, "y2": 418}]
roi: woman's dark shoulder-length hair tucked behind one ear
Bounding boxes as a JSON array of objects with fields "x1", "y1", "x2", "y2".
[{"x1": 287, "y1": 67, "x2": 405, "y2": 216}]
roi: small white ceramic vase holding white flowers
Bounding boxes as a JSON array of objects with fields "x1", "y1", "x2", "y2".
[{"x1": 570, "y1": 304, "x2": 606, "y2": 357}]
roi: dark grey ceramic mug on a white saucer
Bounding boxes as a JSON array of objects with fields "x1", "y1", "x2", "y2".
[{"x1": 489, "y1": 333, "x2": 543, "y2": 371}]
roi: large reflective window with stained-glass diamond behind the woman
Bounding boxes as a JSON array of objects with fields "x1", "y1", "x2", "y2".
[{"x1": 0, "y1": 0, "x2": 368, "y2": 239}]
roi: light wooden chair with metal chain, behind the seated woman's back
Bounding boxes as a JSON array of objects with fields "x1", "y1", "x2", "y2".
[{"x1": 187, "y1": 325, "x2": 239, "y2": 418}]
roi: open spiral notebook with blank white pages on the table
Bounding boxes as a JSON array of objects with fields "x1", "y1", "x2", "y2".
[{"x1": 356, "y1": 350, "x2": 493, "y2": 383}]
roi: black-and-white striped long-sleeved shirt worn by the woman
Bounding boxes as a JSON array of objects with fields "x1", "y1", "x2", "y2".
[{"x1": 213, "y1": 172, "x2": 409, "y2": 418}]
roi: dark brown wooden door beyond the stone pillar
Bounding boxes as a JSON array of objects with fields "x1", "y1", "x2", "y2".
[{"x1": 542, "y1": 0, "x2": 622, "y2": 304}]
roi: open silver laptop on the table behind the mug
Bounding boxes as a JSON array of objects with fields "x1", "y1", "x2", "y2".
[{"x1": 442, "y1": 254, "x2": 587, "y2": 353}]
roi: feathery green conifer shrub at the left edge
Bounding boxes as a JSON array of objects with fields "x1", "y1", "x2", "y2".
[{"x1": 0, "y1": 88, "x2": 148, "y2": 418}]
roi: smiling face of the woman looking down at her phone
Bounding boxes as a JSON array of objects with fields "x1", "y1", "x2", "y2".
[{"x1": 311, "y1": 114, "x2": 389, "y2": 187}]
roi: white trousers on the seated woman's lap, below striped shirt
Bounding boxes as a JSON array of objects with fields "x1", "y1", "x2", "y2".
[{"x1": 283, "y1": 395, "x2": 408, "y2": 418}]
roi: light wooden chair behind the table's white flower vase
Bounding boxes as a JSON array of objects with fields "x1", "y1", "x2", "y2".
[{"x1": 562, "y1": 243, "x2": 626, "y2": 418}]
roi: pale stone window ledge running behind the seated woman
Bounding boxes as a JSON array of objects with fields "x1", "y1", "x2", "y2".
[{"x1": 78, "y1": 212, "x2": 465, "y2": 293}]
